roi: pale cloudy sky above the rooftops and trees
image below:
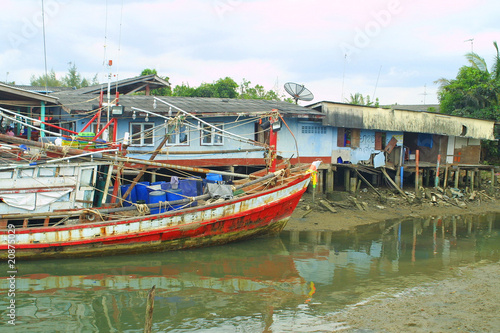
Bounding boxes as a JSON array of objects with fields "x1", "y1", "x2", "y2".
[{"x1": 0, "y1": 0, "x2": 500, "y2": 105}]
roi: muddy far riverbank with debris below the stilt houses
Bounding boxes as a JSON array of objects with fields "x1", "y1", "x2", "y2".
[{"x1": 285, "y1": 186, "x2": 500, "y2": 231}]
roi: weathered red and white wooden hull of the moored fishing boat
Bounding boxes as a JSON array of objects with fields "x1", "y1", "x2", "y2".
[{"x1": 0, "y1": 174, "x2": 310, "y2": 260}]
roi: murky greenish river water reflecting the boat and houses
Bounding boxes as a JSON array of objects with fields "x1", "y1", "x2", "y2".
[{"x1": 0, "y1": 211, "x2": 500, "y2": 332}]
